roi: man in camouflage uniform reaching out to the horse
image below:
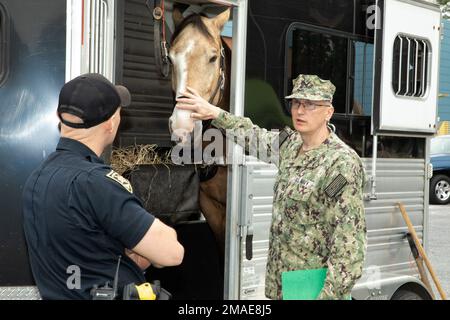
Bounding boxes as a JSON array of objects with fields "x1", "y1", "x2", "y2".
[{"x1": 177, "y1": 74, "x2": 367, "y2": 299}]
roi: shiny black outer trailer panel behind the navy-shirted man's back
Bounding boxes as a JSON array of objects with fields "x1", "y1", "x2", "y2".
[{"x1": 0, "y1": 0, "x2": 66, "y2": 286}]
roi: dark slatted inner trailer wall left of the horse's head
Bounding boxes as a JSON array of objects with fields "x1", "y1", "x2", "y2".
[{"x1": 115, "y1": 0, "x2": 174, "y2": 147}]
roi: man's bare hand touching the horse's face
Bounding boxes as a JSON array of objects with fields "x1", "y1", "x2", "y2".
[{"x1": 175, "y1": 87, "x2": 222, "y2": 120}]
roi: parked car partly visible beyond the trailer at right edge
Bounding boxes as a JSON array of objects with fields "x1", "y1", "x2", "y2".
[{"x1": 430, "y1": 135, "x2": 450, "y2": 204}]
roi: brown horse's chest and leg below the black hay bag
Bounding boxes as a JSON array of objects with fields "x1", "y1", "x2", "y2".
[{"x1": 200, "y1": 167, "x2": 227, "y2": 254}]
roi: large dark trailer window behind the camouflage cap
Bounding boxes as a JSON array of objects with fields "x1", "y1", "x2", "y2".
[{"x1": 285, "y1": 23, "x2": 374, "y2": 117}]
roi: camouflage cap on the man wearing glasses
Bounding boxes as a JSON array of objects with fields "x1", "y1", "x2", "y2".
[{"x1": 285, "y1": 74, "x2": 336, "y2": 102}]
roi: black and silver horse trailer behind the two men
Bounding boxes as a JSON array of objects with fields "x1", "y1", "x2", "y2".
[{"x1": 0, "y1": 0, "x2": 441, "y2": 300}]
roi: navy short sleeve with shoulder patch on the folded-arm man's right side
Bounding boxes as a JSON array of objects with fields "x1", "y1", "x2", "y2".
[{"x1": 77, "y1": 170, "x2": 155, "y2": 249}]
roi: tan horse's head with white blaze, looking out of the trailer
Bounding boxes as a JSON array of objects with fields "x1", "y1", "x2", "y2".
[{"x1": 169, "y1": 10, "x2": 230, "y2": 143}]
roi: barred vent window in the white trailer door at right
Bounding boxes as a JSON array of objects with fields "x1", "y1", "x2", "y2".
[{"x1": 392, "y1": 35, "x2": 431, "y2": 98}]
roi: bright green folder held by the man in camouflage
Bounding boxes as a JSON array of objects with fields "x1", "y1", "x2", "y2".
[{"x1": 281, "y1": 268, "x2": 327, "y2": 300}]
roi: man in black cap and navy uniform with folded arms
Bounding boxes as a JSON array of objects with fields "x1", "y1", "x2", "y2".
[{"x1": 23, "y1": 74, "x2": 184, "y2": 299}]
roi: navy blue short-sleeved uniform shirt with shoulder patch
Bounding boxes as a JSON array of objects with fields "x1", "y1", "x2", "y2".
[{"x1": 23, "y1": 138, "x2": 155, "y2": 299}]
